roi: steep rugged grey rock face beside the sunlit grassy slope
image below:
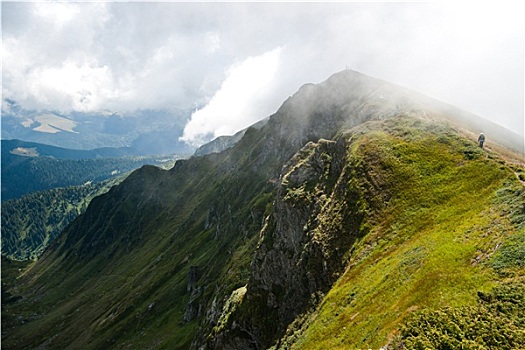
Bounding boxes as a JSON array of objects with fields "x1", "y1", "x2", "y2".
[{"x1": 201, "y1": 133, "x2": 380, "y2": 349}]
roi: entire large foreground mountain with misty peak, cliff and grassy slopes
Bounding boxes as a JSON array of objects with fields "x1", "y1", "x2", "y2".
[{"x1": 2, "y1": 70, "x2": 525, "y2": 349}]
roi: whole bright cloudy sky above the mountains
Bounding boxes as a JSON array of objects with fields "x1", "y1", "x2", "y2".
[{"x1": 1, "y1": 1, "x2": 525, "y2": 146}]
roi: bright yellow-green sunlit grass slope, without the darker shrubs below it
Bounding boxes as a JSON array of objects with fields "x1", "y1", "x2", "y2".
[{"x1": 283, "y1": 118, "x2": 525, "y2": 349}]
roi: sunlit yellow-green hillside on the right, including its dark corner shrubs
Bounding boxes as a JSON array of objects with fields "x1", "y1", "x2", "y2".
[{"x1": 266, "y1": 119, "x2": 525, "y2": 349}]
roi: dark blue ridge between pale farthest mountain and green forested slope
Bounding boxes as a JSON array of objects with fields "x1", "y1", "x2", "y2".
[{"x1": 1, "y1": 140, "x2": 184, "y2": 201}]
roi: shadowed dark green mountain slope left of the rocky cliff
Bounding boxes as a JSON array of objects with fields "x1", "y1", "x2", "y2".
[{"x1": 2, "y1": 129, "x2": 272, "y2": 349}]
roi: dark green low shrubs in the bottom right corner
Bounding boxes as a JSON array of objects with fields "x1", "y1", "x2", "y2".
[{"x1": 395, "y1": 282, "x2": 525, "y2": 350}]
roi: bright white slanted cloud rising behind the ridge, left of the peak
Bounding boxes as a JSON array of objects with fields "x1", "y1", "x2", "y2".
[{"x1": 180, "y1": 48, "x2": 282, "y2": 146}]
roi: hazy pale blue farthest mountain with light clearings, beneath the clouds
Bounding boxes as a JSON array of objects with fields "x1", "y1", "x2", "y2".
[{"x1": 1, "y1": 100, "x2": 194, "y2": 155}]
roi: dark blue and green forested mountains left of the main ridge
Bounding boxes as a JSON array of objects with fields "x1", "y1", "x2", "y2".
[{"x1": 1, "y1": 140, "x2": 184, "y2": 260}]
